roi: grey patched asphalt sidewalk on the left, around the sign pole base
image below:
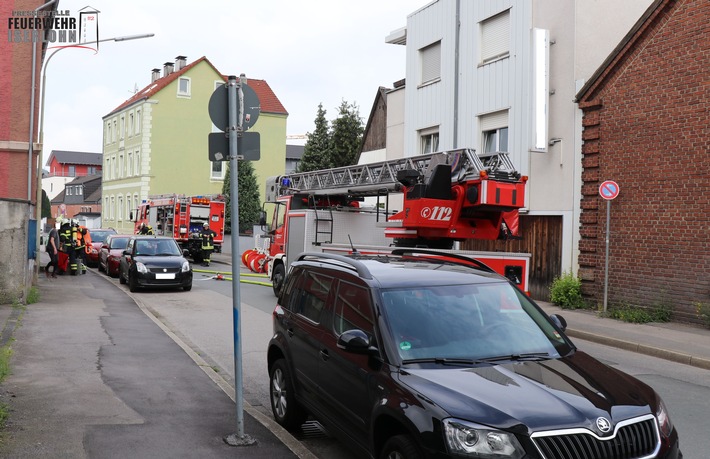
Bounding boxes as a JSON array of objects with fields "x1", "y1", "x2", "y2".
[{"x1": 0, "y1": 260, "x2": 314, "y2": 459}]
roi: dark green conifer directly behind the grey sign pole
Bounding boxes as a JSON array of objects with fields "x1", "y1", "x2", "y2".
[{"x1": 222, "y1": 161, "x2": 261, "y2": 233}]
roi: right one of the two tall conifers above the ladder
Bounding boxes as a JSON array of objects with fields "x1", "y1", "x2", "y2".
[{"x1": 330, "y1": 101, "x2": 365, "y2": 167}]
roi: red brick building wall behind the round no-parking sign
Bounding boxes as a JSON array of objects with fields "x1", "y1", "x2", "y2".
[{"x1": 579, "y1": 0, "x2": 710, "y2": 321}]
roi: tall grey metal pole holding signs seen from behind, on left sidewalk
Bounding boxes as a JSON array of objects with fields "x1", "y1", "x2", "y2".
[{"x1": 225, "y1": 75, "x2": 256, "y2": 446}]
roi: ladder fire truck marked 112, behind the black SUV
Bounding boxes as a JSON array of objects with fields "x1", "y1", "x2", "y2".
[{"x1": 242, "y1": 149, "x2": 530, "y2": 295}]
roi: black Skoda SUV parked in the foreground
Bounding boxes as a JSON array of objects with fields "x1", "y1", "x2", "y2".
[{"x1": 268, "y1": 249, "x2": 682, "y2": 459}]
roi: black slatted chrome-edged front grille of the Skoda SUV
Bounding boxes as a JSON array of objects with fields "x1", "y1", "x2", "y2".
[{"x1": 532, "y1": 416, "x2": 660, "y2": 459}]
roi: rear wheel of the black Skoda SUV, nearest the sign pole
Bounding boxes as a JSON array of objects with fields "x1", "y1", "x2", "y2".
[{"x1": 269, "y1": 359, "x2": 306, "y2": 430}]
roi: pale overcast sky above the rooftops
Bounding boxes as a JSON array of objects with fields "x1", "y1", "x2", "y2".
[{"x1": 38, "y1": 0, "x2": 429, "y2": 166}]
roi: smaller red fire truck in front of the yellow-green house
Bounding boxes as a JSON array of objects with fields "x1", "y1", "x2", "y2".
[{"x1": 134, "y1": 194, "x2": 225, "y2": 263}]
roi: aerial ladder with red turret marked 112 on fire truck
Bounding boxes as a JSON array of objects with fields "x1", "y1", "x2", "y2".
[{"x1": 267, "y1": 149, "x2": 527, "y2": 244}]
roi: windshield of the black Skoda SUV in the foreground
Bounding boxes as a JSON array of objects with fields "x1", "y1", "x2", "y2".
[{"x1": 382, "y1": 283, "x2": 571, "y2": 363}]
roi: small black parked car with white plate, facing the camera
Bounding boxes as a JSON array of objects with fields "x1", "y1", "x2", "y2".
[{"x1": 118, "y1": 236, "x2": 192, "y2": 292}]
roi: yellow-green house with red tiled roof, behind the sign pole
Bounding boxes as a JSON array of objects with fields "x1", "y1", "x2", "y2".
[{"x1": 101, "y1": 56, "x2": 288, "y2": 233}]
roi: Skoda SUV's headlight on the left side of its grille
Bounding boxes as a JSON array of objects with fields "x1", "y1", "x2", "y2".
[{"x1": 444, "y1": 418, "x2": 525, "y2": 459}]
